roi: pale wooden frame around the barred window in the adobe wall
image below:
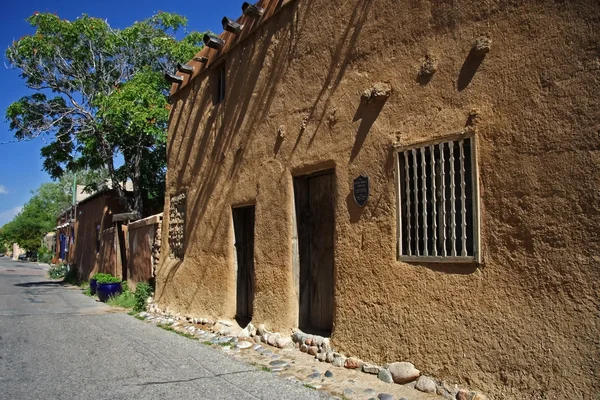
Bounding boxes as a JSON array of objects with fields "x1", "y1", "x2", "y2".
[{"x1": 393, "y1": 132, "x2": 482, "y2": 264}]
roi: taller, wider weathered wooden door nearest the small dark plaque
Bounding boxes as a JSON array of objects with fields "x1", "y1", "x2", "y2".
[{"x1": 294, "y1": 172, "x2": 335, "y2": 334}]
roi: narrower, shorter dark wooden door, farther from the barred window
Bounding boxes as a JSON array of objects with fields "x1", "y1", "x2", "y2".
[{"x1": 233, "y1": 206, "x2": 254, "y2": 321}]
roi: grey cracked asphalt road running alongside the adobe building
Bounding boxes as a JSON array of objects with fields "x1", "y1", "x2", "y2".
[{"x1": 0, "y1": 257, "x2": 326, "y2": 400}]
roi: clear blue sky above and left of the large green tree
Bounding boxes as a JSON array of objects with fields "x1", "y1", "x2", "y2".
[{"x1": 0, "y1": 0, "x2": 243, "y2": 226}]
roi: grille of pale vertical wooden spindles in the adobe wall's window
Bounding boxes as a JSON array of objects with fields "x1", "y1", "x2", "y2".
[{"x1": 398, "y1": 137, "x2": 479, "y2": 261}]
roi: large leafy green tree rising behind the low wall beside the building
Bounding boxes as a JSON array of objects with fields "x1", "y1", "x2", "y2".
[{"x1": 6, "y1": 12, "x2": 203, "y2": 214}]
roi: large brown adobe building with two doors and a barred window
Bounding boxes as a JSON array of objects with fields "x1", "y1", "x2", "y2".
[{"x1": 156, "y1": 0, "x2": 600, "y2": 399}]
